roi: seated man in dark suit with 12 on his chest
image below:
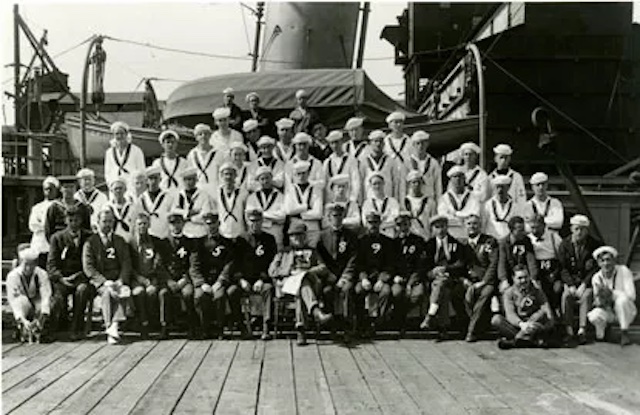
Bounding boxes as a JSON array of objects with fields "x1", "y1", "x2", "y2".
[{"x1": 464, "y1": 215, "x2": 498, "y2": 342}]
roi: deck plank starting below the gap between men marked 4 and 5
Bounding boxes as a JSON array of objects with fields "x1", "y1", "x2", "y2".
[{"x1": 132, "y1": 341, "x2": 211, "y2": 414}]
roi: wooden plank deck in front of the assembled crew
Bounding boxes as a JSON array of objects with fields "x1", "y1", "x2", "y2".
[{"x1": 2, "y1": 336, "x2": 640, "y2": 415}]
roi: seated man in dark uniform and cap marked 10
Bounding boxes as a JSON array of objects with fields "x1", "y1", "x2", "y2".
[{"x1": 391, "y1": 211, "x2": 427, "y2": 336}]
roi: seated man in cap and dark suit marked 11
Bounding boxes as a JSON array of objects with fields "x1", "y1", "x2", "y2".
[{"x1": 420, "y1": 215, "x2": 469, "y2": 341}]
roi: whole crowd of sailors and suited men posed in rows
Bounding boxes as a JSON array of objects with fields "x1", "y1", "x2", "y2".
[{"x1": 7, "y1": 90, "x2": 636, "y2": 347}]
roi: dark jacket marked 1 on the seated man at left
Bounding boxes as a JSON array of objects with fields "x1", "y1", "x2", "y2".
[{"x1": 47, "y1": 228, "x2": 91, "y2": 283}]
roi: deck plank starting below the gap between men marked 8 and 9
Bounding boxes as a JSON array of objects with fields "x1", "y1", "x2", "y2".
[{"x1": 351, "y1": 342, "x2": 420, "y2": 415}]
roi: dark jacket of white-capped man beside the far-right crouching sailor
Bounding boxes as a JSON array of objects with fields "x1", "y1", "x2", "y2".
[{"x1": 558, "y1": 235, "x2": 602, "y2": 287}]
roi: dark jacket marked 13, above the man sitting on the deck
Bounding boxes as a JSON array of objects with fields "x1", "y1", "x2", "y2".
[{"x1": 498, "y1": 234, "x2": 538, "y2": 284}]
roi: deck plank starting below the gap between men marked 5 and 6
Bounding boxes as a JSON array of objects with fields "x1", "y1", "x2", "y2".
[{"x1": 174, "y1": 341, "x2": 238, "y2": 414}]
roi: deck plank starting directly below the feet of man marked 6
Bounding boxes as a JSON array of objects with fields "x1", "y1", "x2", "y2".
[{"x1": 216, "y1": 341, "x2": 265, "y2": 415}]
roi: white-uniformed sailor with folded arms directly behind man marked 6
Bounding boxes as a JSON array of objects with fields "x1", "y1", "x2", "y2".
[{"x1": 247, "y1": 166, "x2": 286, "y2": 250}]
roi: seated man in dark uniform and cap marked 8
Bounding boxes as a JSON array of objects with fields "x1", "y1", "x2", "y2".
[{"x1": 318, "y1": 202, "x2": 358, "y2": 340}]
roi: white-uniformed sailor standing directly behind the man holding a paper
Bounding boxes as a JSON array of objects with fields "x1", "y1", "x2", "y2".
[{"x1": 284, "y1": 161, "x2": 323, "y2": 247}]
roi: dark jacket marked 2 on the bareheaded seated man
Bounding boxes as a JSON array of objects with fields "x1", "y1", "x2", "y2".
[{"x1": 82, "y1": 233, "x2": 131, "y2": 288}]
